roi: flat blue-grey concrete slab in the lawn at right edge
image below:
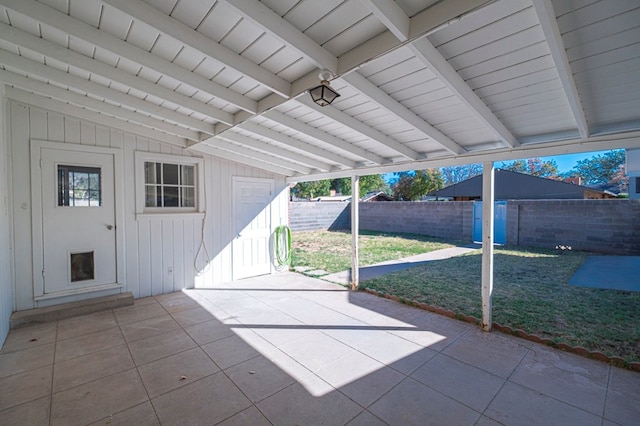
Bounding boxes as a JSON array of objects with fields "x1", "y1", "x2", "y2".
[{"x1": 569, "y1": 256, "x2": 640, "y2": 291}]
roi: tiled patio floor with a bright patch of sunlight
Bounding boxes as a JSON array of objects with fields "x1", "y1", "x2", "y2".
[{"x1": 0, "y1": 273, "x2": 640, "y2": 426}]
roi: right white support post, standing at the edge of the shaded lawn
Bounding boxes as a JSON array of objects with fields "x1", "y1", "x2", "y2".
[{"x1": 482, "y1": 161, "x2": 494, "y2": 331}]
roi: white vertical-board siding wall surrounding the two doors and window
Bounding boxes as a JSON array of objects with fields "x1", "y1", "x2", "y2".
[{"x1": 10, "y1": 102, "x2": 288, "y2": 310}]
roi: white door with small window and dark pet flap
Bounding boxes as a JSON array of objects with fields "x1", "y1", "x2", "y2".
[{"x1": 40, "y1": 148, "x2": 117, "y2": 295}]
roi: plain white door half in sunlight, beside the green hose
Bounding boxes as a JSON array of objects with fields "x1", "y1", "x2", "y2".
[{"x1": 232, "y1": 177, "x2": 274, "y2": 280}]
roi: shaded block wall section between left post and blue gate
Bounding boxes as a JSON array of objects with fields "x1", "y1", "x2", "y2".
[{"x1": 360, "y1": 201, "x2": 473, "y2": 241}]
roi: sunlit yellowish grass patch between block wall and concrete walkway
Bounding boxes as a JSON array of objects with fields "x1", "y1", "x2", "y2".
[{"x1": 291, "y1": 231, "x2": 453, "y2": 273}]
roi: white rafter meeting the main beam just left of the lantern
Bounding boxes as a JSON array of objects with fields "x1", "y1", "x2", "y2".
[{"x1": 102, "y1": 0, "x2": 291, "y2": 98}]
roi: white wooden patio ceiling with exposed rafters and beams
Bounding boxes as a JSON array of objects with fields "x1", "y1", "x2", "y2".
[{"x1": 0, "y1": 0, "x2": 640, "y2": 181}]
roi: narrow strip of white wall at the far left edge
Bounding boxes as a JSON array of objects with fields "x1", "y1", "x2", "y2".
[{"x1": 0, "y1": 93, "x2": 13, "y2": 347}]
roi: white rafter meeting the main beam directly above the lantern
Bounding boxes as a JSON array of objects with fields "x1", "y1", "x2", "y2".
[{"x1": 223, "y1": 0, "x2": 338, "y2": 73}]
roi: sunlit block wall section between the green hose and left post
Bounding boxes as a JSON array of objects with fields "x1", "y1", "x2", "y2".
[{"x1": 289, "y1": 201, "x2": 350, "y2": 231}]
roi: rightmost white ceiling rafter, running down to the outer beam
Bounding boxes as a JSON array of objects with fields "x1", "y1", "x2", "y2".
[{"x1": 533, "y1": 0, "x2": 590, "y2": 138}]
